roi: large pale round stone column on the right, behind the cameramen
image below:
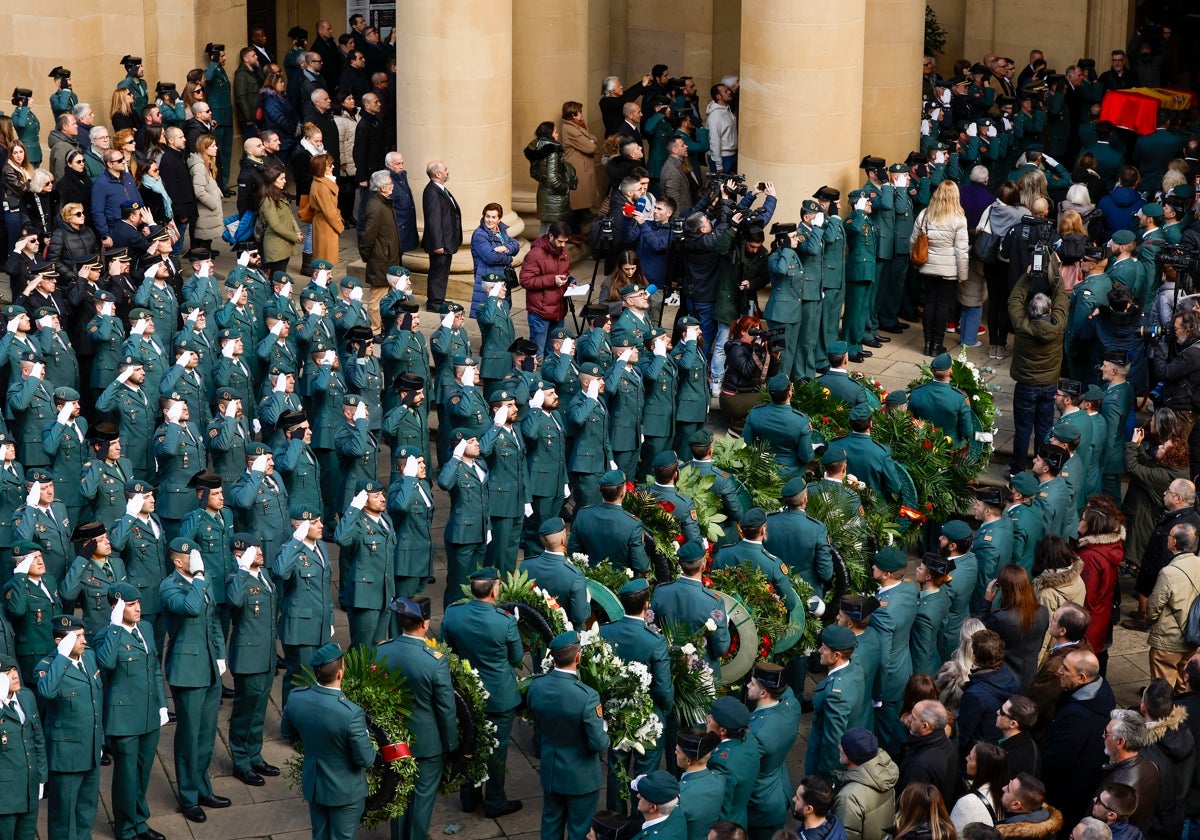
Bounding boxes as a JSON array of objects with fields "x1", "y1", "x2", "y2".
[{"x1": 738, "y1": 0, "x2": 864, "y2": 220}]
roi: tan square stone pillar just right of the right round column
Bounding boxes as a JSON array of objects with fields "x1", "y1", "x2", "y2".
[{"x1": 862, "y1": 0, "x2": 925, "y2": 163}]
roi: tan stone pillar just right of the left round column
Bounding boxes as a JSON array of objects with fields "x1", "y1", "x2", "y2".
[{"x1": 512, "y1": 0, "x2": 589, "y2": 219}]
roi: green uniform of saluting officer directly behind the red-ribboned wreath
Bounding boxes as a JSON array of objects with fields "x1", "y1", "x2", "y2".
[{"x1": 334, "y1": 506, "x2": 396, "y2": 648}]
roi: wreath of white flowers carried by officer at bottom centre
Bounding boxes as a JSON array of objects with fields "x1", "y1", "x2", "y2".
[{"x1": 542, "y1": 630, "x2": 662, "y2": 798}]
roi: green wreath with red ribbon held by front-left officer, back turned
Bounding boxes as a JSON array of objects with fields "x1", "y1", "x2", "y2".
[{"x1": 284, "y1": 646, "x2": 416, "y2": 828}]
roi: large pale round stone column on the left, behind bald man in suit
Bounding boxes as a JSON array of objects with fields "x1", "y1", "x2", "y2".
[{"x1": 396, "y1": 0, "x2": 515, "y2": 291}]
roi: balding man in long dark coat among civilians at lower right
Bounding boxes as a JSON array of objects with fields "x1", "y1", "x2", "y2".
[{"x1": 1042, "y1": 650, "x2": 1117, "y2": 826}]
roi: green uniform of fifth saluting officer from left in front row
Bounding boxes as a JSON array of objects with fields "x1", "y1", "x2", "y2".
[{"x1": 224, "y1": 568, "x2": 278, "y2": 773}]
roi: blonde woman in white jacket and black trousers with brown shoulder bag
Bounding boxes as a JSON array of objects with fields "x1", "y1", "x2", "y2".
[{"x1": 908, "y1": 181, "x2": 979, "y2": 356}]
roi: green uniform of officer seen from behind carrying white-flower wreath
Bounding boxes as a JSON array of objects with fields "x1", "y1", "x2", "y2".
[{"x1": 526, "y1": 668, "x2": 608, "y2": 840}]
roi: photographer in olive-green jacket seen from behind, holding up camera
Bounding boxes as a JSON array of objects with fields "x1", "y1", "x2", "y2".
[{"x1": 1008, "y1": 260, "x2": 1069, "y2": 475}]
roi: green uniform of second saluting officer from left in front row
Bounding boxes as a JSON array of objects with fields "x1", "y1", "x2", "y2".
[{"x1": 37, "y1": 650, "x2": 104, "y2": 840}]
